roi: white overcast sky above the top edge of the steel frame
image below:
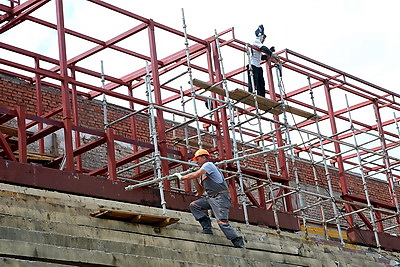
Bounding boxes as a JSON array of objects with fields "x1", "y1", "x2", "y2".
[{"x1": 112, "y1": 0, "x2": 400, "y2": 92}]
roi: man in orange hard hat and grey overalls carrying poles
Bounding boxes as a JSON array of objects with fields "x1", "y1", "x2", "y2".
[{"x1": 179, "y1": 149, "x2": 244, "y2": 248}]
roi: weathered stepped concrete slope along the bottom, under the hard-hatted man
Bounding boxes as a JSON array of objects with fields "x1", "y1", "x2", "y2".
[{"x1": 0, "y1": 184, "x2": 400, "y2": 267}]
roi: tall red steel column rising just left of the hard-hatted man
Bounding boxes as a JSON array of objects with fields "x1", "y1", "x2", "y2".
[{"x1": 148, "y1": 20, "x2": 171, "y2": 190}]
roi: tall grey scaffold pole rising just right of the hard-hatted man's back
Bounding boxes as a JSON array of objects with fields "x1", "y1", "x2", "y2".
[{"x1": 215, "y1": 30, "x2": 249, "y2": 224}]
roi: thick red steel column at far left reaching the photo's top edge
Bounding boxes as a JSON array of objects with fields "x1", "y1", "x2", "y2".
[{"x1": 56, "y1": 0, "x2": 74, "y2": 170}]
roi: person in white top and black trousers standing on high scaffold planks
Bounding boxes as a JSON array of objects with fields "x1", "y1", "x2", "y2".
[{"x1": 247, "y1": 25, "x2": 276, "y2": 97}]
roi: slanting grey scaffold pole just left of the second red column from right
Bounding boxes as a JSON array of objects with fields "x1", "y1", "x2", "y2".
[{"x1": 307, "y1": 76, "x2": 344, "y2": 246}]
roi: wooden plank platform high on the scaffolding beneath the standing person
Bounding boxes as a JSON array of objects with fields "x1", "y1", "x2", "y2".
[{"x1": 193, "y1": 79, "x2": 319, "y2": 120}]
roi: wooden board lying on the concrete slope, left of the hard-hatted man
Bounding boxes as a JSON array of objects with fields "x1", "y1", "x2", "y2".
[{"x1": 90, "y1": 209, "x2": 179, "y2": 227}]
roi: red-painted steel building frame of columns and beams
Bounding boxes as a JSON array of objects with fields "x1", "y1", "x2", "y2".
[{"x1": 0, "y1": 0, "x2": 400, "y2": 249}]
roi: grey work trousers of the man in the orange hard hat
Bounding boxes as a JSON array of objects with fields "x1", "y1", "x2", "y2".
[{"x1": 189, "y1": 193, "x2": 238, "y2": 240}]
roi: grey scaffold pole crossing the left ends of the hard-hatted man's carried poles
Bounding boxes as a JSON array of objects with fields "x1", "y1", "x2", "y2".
[{"x1": 146, "y1": 61, "x2": 167, "y2": 215}]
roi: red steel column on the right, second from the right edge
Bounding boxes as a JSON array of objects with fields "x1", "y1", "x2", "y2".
[{"x1": 324, "y1": 81, "x2": 354, "y2": 227}]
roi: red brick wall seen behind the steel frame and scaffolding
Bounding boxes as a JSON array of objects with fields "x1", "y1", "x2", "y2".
[{"x1": 0, "y1": 74, "x2": 399, "y2": 210}]
